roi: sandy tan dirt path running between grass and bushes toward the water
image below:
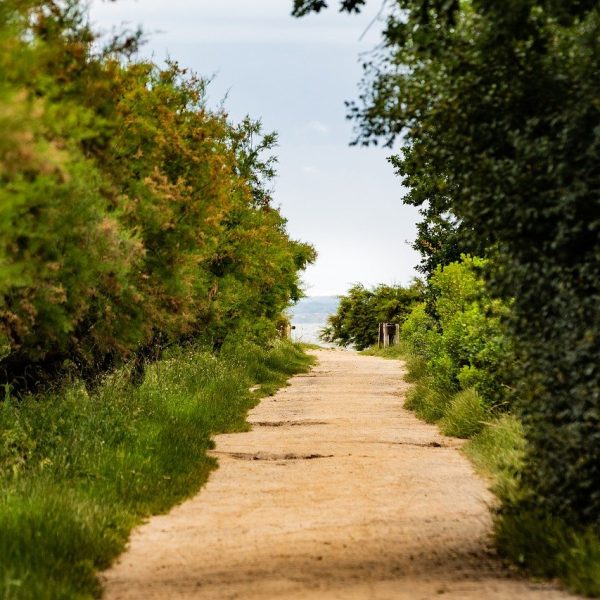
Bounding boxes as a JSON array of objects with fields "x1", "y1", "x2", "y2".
[{"x1": 105, "y1": 351, "x2": 571, "y2": 600}]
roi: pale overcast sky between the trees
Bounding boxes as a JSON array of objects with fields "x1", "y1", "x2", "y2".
[{"x1": 91, "y1": 0, "x2": 418, "y2": 296}]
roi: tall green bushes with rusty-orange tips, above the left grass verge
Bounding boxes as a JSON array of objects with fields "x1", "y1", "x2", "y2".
[{"x1": 0, "y1": 0, "x2": 314, "y2": 384}]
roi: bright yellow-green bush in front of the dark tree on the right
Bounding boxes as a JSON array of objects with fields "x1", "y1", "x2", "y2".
[{"x1": 360, "y1": 255, "x2": 514, "y2": 438}]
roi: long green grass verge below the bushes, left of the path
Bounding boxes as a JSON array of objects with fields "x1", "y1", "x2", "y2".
[{"x1": 0, "y1": 342, "x2": 311, "y2": 600}]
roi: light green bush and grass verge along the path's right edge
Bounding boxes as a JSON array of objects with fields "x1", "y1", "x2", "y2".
[{"x1": 332, "y1": 255, "x2": 600, "y2": 596}]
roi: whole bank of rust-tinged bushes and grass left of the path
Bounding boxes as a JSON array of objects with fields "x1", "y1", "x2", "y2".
[{"x1": 0, "y1": 0, "x2": 315, "y2": 600}]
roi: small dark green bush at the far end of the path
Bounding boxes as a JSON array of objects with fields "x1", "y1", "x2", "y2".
[{"x1": 321, "y1": 280, "x2": 423, "y2": 350}]
